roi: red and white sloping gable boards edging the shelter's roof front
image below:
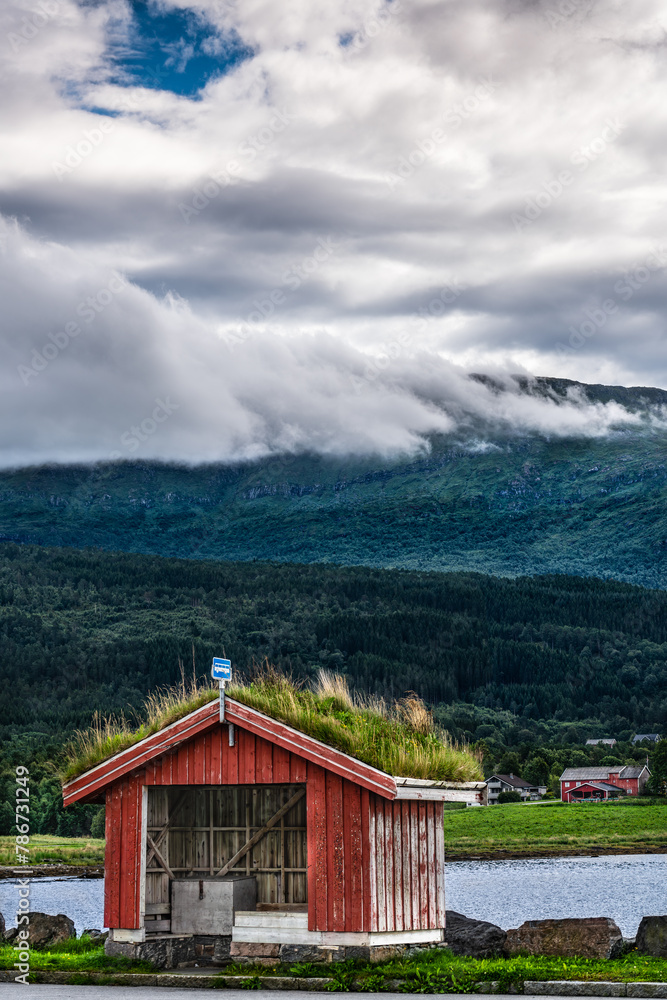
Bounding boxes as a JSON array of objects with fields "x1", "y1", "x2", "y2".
[{"x1": 63, "y1": 698, "x2": 397, "y2": 805}]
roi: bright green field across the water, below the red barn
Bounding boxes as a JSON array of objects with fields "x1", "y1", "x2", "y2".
[{"x1": 445, "y1": 799, "x2": 667, "y2": 860}]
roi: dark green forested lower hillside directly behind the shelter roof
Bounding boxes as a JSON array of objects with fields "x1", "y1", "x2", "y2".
[{"x1": 0, "y1": 543, "x2": 667, "y2": 738}]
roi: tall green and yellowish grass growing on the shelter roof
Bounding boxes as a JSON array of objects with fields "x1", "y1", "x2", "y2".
[{"x1": 62, "y1": 664, "x2": 482, "y2": 781}]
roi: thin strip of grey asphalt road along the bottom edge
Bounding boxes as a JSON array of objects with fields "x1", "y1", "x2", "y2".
[{"x1": 0, "y1": 983, "x2": 572, "y2": 1000}]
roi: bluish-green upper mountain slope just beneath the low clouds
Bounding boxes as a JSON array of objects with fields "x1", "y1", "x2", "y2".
[{"x1": 0, "y1": 402, "x2": 667, "y2": 587}]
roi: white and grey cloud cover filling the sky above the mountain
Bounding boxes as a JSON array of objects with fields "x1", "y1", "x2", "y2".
[{"x1": 0, "y1": 0, "x2": 667, "y2": 463}]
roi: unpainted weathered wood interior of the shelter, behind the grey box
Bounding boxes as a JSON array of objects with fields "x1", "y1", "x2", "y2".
[{"x1": 144, "y1": 785, "x2": 308, "y2": 933}]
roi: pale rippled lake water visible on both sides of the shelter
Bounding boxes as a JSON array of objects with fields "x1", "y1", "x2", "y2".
[{"x1": 0, "y1": 854, "x2": 667, "y2": 937}]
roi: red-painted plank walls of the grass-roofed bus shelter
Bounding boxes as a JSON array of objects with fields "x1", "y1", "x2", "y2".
[{"x1": 105, "y1": 726, "x2": 445, "y2": 931}]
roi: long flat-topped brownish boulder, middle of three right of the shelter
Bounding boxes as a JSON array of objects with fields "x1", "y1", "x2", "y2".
[{"x1": 505, "y1": 917, "x2": 623, "y2": 958}]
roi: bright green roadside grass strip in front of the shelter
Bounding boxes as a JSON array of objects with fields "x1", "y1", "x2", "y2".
[{"x1": 5, "y1": 938, "x2": 667, "y2": 993}]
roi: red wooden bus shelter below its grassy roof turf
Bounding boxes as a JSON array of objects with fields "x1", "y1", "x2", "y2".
[{"x1": 63, "y1": 698, "x2": 486, "y2": 967}]
